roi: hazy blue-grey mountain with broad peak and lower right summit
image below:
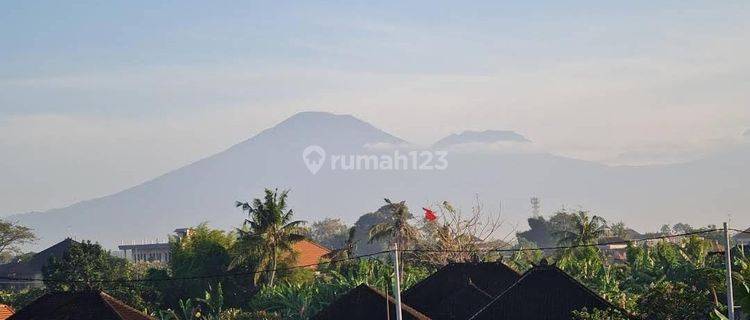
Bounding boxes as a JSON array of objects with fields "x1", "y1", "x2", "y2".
[{"x1": 9, "y1": 112, "x2": 750, "y2": 250}]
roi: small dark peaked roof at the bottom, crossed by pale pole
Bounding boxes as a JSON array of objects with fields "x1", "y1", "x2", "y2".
[{"x1": 312, "y1": 284, "x2": 430, "y2": 320}]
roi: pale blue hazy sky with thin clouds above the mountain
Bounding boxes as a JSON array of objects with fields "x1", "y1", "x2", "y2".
[{"x1": 0, "y1": 1, "x2": 750, "y2": 213}]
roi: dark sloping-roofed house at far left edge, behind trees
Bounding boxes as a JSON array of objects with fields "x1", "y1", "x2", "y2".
[{"x1": 0, "y1": 238, "x2": 76, "y2": 288}]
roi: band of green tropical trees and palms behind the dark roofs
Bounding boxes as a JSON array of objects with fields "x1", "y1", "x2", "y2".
[{"x1": 0, "y1": 189, "x2": 750, "y2": 320}]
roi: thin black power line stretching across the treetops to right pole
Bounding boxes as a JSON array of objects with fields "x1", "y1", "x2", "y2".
[{"x1": 0, "y1": 229, "x2": 728, "y2": 283}]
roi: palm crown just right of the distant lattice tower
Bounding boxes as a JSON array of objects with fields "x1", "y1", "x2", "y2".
[{"x1": 553, "y1": 210, "x2": 607, "y2": 246}]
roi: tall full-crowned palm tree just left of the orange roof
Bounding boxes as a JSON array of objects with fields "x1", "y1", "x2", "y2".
[{"x1": 232, "y1": 189, "x2": 305, "y2": 286}]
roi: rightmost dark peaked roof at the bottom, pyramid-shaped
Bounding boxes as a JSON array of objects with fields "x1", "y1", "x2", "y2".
[{"x1": 470, "y1": 265, "x2": 616, "y2": 320}]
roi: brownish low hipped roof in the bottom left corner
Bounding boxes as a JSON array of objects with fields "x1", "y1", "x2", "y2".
[{"x1": 8, "y1": 291, "x2": 155, "y2": 320}]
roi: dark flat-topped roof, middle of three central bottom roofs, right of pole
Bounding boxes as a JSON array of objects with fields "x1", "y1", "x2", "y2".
[{"x1": 402, "y1": 262, "x2": 521, "y2": 319}]
